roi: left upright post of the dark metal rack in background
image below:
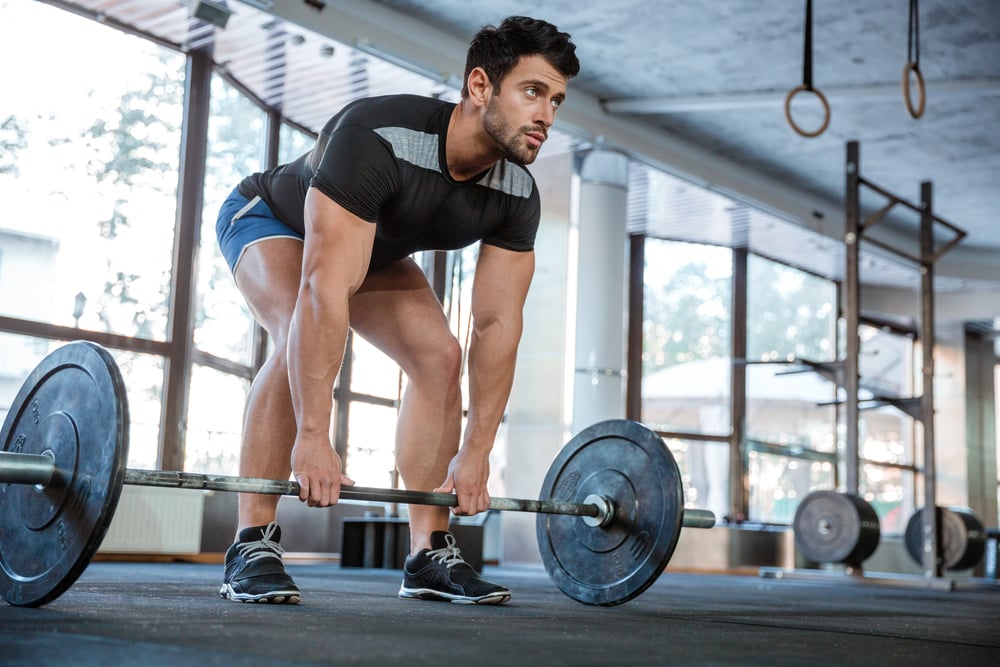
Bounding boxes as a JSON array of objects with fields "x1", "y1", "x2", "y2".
[{"x1": 843, "y1": 141, "x2": 861, "y2": 493}]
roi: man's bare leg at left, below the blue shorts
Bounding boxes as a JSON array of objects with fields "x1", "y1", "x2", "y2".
[{"x1": 236, "y1": 238, "x2": 302, "y2": 536}]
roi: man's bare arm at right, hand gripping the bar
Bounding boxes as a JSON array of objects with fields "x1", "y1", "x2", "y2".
[{"x1": 439, "y1": 244, "x2": 535, "y2": 514}]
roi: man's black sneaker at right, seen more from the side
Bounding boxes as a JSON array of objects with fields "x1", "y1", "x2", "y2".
[{"x1": 399, "y1": 530, "x2": 510, "y2": 604}]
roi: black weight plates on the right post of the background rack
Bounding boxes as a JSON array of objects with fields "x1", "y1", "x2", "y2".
[{"x1": 904, "y1": 507, "x2": 986, "y2": 571}]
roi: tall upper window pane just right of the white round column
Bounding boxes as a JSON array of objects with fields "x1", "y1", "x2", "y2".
[{"x1": 642, "y1": 239, "x2": 732, "y2": 435}]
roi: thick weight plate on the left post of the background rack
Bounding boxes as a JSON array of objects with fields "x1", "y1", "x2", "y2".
[{"x1": 792, "y1": 491, "x2": 881, "y2": 565}]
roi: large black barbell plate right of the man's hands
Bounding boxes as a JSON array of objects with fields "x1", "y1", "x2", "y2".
[{"x1": 536, "y1": 419, "x2": 684, "y2": 606}]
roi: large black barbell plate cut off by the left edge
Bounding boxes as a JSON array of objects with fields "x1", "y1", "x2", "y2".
[{"x1": 0, "y1": 342, "x2": 128, "y2": 607}]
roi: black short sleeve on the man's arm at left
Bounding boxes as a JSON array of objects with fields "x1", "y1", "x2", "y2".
[{"x1": 310, "y1": 125, "x2": 399, "y2": 222}]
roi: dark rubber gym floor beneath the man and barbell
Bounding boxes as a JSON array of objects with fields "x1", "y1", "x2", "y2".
[{"x1": 0, "y1": 562, "x2": 1000, "y2": 667}]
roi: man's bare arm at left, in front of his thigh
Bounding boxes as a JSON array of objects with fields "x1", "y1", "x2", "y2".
[{"x1": 288, "y1": 188, "x2": 375, "y2": 507}]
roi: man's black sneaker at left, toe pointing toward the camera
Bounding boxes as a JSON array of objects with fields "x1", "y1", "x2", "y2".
[{"x1": 219, "y1": 521, "x2": 302, "y2": 604}]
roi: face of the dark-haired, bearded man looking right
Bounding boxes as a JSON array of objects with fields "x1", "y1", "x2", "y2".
[{"x1": 483, "y1": 56, "x2": 567, "y2": 164}]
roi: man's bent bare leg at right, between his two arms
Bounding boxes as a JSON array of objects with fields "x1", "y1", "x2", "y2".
[{"x1": 350, "y1": 260, "x2": 462, "y2": 553}]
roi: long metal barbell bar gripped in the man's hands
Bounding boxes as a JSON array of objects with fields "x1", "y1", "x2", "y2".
[{"x1": 0, "y1": 452, "x2": 715, "y2": 528}]
